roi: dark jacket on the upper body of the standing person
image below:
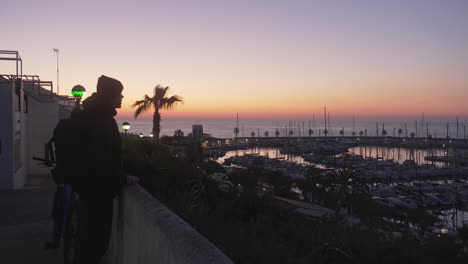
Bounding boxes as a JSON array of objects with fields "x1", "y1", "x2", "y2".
[{"x1": 74, "y1": 93, "x2": 123, "y2": 197}]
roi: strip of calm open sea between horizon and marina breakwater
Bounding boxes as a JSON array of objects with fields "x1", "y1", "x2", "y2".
[{"x1": 116, "y1": 117, "x2": 468, "y2": 138}]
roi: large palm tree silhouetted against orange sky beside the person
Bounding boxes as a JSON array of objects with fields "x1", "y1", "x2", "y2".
[{"x1": 132, "y1": 84, "x2": 183, "y2": 141}]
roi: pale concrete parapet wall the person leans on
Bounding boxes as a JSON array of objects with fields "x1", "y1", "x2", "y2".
[{"x1": 109, "y1": 185, "x2": 232, "y2": 264}]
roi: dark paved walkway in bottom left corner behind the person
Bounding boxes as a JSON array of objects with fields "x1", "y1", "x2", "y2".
[{"x1": 0, "y1": 187, "x2": 63, "y2": 264}]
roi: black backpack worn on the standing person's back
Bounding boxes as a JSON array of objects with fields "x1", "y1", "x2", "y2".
[{"x1": 49, "y1": 108, "x2": 86, "y2": 185}]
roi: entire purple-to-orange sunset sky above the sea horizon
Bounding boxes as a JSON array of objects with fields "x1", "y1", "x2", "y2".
[{"x1": 0, "y1": 0, "x2": 468, "y2": 118}]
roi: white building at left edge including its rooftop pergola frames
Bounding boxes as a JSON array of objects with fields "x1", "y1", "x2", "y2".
[{"x1": 0, "y1": 51, "x2": 73, "y2": 189}]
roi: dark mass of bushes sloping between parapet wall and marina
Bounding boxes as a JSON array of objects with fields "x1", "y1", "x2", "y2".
[{"x1": 123, "y1": 138, "x2": 467, "y2": 264}]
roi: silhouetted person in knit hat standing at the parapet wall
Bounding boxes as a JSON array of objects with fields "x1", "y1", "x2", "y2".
[{"x1": 73, "y1": 75, "x2": 134, "y2": 264}]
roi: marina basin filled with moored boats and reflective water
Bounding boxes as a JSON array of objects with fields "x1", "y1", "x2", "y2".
[{"x1": 207, "y1": 138, "x2": 468, "y2": 229}]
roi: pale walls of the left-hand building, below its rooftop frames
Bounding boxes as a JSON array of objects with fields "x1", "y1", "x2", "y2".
[{"x1": 0, "y1": 76, "x2": 70, "y2": 189}]
